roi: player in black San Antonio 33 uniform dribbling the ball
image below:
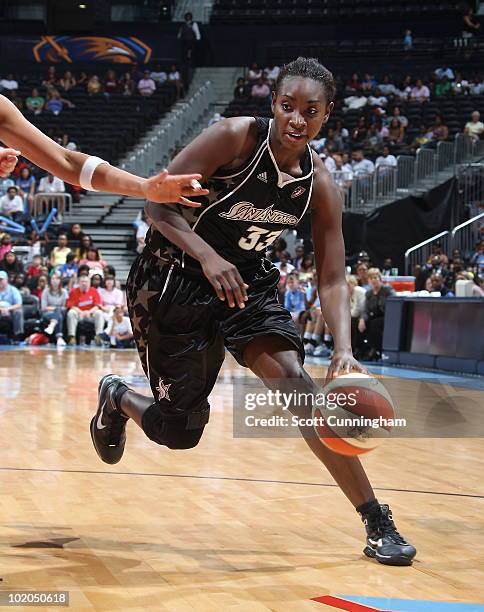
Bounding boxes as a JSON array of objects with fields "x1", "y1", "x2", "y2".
[{"x1": 91, "y1": 58, "x2": 416, "y2": 565}]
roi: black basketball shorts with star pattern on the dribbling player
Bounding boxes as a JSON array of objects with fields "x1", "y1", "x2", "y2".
[{"x1": 126, "y1": 252, "x2": 304, "y2": 414}]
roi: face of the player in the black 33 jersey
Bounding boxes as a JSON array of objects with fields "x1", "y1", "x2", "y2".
[{"x1": 272, "y1": 77, "x2": 333, "y2": 148}]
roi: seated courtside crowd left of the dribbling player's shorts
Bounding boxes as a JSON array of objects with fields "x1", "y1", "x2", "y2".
[{"x1": 0, "y1": 223, "x2": 134, "y2": 348}]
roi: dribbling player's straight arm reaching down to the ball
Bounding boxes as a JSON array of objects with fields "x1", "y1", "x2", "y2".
[{"x1": 311, "y1": 156, "x2": 366, "y2": 380}]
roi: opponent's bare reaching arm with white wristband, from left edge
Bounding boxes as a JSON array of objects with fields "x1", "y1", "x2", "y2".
[{"x1": 0, "y1": 95, "x2": 206, "y2": 207}]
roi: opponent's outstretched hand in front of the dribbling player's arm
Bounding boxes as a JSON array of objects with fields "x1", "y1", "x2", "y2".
[{"x1": 142, "y1": 170, "x2": 208, "y2": 207}]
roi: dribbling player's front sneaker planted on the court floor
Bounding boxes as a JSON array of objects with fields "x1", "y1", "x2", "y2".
[{"x1": 361, "y1": 504, "x2": 417, "y2": 565}]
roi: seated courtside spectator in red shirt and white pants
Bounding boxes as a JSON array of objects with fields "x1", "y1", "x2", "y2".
[{"x1": 67, "y1": 275, "x2": 104, "y2": 346}]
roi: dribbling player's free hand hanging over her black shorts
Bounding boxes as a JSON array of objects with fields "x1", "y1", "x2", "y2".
[{"x1": 200, "y1": 253, "x2": 249, "y2": 308}]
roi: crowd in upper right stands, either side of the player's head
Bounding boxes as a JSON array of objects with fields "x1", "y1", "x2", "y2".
[{"x1": 225, "y1": 62, "x2": 484, "y2": 186}]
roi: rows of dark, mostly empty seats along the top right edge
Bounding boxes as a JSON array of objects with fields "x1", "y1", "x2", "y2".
[{"x1": 211, "y1": 0, "x2": 460, "y2": 23}]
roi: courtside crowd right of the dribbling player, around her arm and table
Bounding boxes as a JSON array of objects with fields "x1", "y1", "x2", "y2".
[{"x1": 271, "y1": 234, "x2": 484, "y2": 361}]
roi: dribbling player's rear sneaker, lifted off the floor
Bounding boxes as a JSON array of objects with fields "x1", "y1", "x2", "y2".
[{"x1": 90, "y1": 374, "x2": 129, "y2": 464}]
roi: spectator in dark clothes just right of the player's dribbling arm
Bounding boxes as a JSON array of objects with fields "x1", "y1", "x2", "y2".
[{"x1": 358, "y1": 268, "x2": 395, "y2": 361}]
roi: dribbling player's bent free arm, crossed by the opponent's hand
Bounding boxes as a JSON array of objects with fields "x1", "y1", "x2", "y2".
[{"x1": 145, "y1": 117, "x2": 257, "y2": 308}]
